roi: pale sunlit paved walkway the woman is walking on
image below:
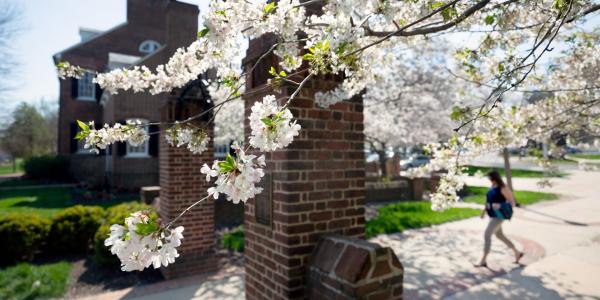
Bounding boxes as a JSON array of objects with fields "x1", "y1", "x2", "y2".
[{"x1": 85, "y1": 171, "x2": 600, "y2": 300}]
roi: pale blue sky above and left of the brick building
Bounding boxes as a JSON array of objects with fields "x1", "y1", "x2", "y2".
[{"x1": 0, "y1": 0, "x2": 208, "y2": 112}]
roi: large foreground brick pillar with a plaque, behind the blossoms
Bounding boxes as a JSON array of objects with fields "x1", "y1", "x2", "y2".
[{"x1": 244, "y1": 38, "x2": 365, "y2": 299}]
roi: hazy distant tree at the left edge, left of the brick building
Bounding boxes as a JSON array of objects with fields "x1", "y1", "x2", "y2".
[{"x1": 0, "y1": 103, "x2": 56, "y2": 170}]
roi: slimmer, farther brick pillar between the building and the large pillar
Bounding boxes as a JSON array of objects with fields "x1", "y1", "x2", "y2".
[{"x1": 159, "y1": 99, "x2": 217, "y2": 278}]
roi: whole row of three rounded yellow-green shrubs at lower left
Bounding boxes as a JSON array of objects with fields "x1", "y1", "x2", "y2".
[{"x1": 0, "y1": 202, "x2": 151, "y2": 266}]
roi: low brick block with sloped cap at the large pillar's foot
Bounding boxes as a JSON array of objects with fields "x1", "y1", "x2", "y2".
[{"x1": 307, "y1": 236, "x2": 404, "y2": 300}]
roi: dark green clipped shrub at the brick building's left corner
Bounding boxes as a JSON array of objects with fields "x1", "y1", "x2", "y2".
[{"x1": 23, "y1": 155, "x2": 69, "y2": 181}]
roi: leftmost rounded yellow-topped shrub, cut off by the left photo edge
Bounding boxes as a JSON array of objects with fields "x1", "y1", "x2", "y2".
[{"x1": 0, "y1": 214, "x2": 50, "y2": 263}]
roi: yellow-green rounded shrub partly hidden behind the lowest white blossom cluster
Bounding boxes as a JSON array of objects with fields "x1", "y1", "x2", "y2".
[{"x1": 94, "y1": 202, "x2": 156, "y2": 267}]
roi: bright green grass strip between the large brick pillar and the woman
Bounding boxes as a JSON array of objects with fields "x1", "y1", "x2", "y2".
[{"x1": 365, "y1": 201, "x2": 481, "y2": 238}]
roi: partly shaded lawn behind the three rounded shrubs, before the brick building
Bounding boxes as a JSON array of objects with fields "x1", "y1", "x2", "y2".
[{"x1": 0, "y1": 187, "x2": 135, "y2": 217}]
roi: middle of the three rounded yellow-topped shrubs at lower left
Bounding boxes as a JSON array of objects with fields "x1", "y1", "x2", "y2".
[{"x1": 48, "y1": 205, "x2": 104, "y2": 253}]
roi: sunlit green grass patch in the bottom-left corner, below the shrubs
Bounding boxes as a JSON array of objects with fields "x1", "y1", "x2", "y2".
[{"x1": 0, "y1": 260, "x2": 71, "y2": 300}]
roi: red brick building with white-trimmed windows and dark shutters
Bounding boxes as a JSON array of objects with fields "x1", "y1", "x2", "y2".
[{"x1": 53, "y1": 0, "x2": 199, "y2": 188}]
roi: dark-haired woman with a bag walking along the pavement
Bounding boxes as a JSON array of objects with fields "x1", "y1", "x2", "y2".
[{"x1": 476, "y1": 171, "x2": 523, "y2": 267}]
